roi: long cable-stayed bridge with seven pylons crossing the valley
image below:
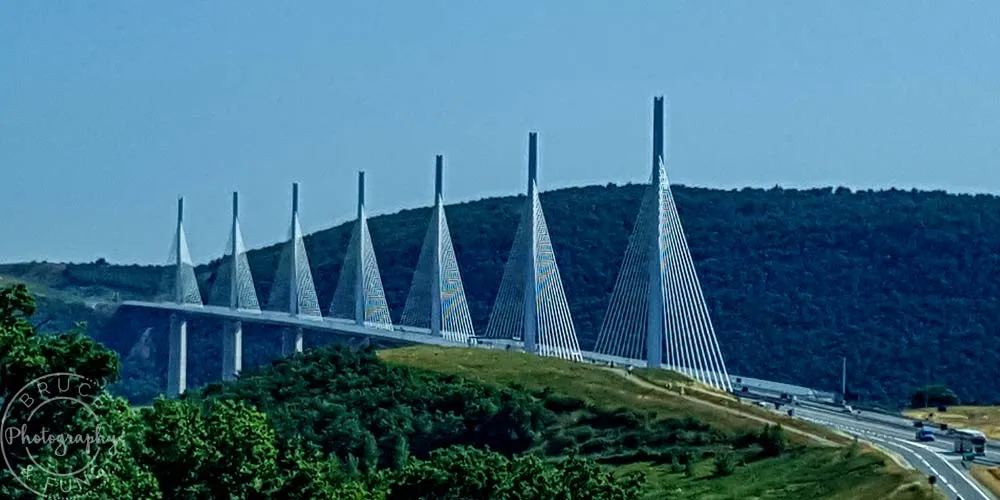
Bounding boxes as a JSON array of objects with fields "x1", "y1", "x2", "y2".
[{"x1": 123, "y1": 97, "x2": 732, "y2": 396}]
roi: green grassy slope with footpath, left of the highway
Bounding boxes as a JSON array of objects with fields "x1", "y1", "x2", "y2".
[{"x1": 379, "y1": 346, "x2": 935, "y2": 500}]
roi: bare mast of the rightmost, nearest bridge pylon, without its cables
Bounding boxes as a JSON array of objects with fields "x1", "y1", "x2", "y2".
[{"x1": 646, "y1": 97, "x2": 666, "y2": 368}]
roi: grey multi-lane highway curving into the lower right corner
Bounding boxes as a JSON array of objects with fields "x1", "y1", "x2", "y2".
[{"x1": 795, "y1": 405, "x2": 1000, "y2": 500}]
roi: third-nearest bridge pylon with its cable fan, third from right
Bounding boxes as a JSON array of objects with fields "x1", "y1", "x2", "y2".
[{"x1": 400, "y1": 155, "x2": 476, "y2": 343}]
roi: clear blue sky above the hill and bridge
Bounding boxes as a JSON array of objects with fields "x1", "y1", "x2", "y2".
[{"x1": 0, "y1": 1, "x2": 1000, "y2": 263}]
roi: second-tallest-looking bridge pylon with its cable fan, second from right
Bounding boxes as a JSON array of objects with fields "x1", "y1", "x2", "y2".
[{"x1": 484, "y1": 132, "x2": 583, "y2": 361}]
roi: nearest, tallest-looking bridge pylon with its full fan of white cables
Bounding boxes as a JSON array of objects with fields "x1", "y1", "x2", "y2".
[{"x1": 594, "y1": 97, "x2": 732, "y2": 391}]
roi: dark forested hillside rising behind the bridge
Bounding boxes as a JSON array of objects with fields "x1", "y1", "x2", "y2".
[{"x1": 0, "y1": 185, "x2": 1000, "y2": 402}]
